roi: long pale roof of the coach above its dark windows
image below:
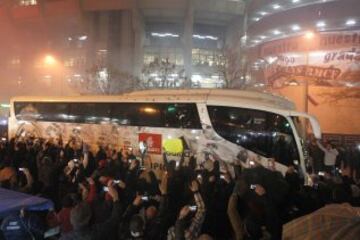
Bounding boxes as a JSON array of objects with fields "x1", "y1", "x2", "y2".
[{"x1": 11, "y1": 89, "x2": 295, "y2": 110}]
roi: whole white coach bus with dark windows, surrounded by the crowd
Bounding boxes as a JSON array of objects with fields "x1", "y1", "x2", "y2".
[{"x1": 9, "y1": 89, "x2": 321, "y2": 176}]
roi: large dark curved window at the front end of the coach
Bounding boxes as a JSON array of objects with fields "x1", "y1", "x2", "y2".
[{"x1": 208, "y1": 106, "x2": 299, "y2": 166}]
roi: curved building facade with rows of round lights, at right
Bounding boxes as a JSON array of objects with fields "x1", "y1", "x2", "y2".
[{"x1": 246, "y1": 0, "x2": 360, "y2": 143}]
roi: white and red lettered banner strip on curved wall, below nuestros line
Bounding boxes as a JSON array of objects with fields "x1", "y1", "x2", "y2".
[{"x1": 264, "y1": 48, "x2": 360, "y2": 87}]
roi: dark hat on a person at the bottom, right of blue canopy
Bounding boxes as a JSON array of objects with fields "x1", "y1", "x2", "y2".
[{"x1": 70, "y1": 203, "x2": 91, "y2": 230}]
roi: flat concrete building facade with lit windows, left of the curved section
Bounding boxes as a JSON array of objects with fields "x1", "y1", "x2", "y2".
[{"x1": 0, "y1": 0, "x2": 245, "y2": 101}]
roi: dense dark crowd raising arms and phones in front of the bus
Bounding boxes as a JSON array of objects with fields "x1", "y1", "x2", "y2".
[{"x1": 0, "y1": 138, "x2": 360, "y2": 240}]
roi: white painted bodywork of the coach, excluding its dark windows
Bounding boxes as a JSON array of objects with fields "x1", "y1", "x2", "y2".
[{"x1": 9, "y1": 89, "x2": 314, "y2": 173}]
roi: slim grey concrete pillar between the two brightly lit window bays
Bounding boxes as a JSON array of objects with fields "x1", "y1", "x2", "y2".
[{"x1": 182, "y1": 0, "x2": 195, "y2": 87}]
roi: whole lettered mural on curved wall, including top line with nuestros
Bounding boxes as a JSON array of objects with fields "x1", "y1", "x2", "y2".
[{"x1": 260, "y1": 32, "x2": 360, "y2": 87}]
